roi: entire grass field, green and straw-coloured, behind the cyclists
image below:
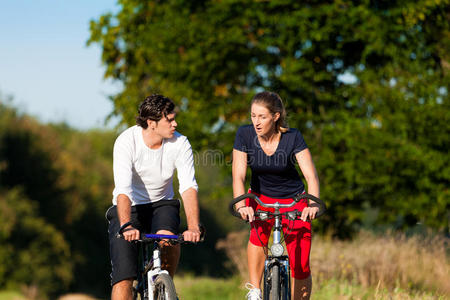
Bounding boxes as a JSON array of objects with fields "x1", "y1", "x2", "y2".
[{"x1": 0, "y1": 232, "x2": 450, "y2": 300}]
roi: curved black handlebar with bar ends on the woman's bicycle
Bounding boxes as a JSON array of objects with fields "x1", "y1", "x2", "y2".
[{"x1": 229, "y1": 193, "x2": 327, "y2": 218}]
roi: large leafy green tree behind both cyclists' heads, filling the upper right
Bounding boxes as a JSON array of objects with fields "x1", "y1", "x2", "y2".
[{"x1": 88, "y1": 0, "x2": 450, "y2": 236}]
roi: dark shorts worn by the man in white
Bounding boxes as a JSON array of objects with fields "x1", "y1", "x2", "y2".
[{"x1": 106, "y1": 200, "x2": 180, "y2": 285}]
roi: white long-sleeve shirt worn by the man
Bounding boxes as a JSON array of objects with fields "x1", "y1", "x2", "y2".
[{"x1": 113, "y1": 125, "x2": 198, "y2": 205}]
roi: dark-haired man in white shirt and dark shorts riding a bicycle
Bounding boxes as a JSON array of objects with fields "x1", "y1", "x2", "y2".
[{"x1": 106, "y1": 95, "x2": 200, "y2": 300}]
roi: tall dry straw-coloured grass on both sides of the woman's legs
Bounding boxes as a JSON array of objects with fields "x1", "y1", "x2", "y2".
[{"x1": 218, "y1": 231, "x2": 450, "y2": 296}]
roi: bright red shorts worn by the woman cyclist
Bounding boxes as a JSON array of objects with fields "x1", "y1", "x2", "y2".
[{"x1": 246, "y1": 192, "x2": 311, "y2": 279}]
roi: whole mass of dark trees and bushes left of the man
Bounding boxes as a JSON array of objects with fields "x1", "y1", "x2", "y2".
[{"x1": 0, "y1": 99, "x2": 116, "y2": 298}]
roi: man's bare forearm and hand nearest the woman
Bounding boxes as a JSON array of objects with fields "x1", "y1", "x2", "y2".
[{"x1": 181, "y1": 188, "x2": 200, "y2": 242}]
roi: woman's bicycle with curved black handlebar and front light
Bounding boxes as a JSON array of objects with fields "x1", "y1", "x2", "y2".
[{"x1": 229, "y1": 193, "x2": 326, "y2": 300}]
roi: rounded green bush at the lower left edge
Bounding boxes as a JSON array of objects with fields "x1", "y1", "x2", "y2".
[{"x1": 0, "y1": 188, "x2": 73, "y2": 294}]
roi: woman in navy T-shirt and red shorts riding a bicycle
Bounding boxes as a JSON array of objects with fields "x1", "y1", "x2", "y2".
[{"x1": 232, "y1": 92, "x2": 319, "y2": 300}]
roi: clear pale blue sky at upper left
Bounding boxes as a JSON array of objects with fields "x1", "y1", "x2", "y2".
[{"x1": 0, "y1": 0, "x2": 120, "y2": 129}]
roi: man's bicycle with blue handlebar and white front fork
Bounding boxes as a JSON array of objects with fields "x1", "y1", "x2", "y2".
[{"x1": 116, "y1": 223, "x2": 205, "y2": 300}]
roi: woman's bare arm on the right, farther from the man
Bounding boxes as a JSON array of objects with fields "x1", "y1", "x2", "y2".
[{"x1": 295, "y1": 148, "x2": 320, "y2": 221}]
